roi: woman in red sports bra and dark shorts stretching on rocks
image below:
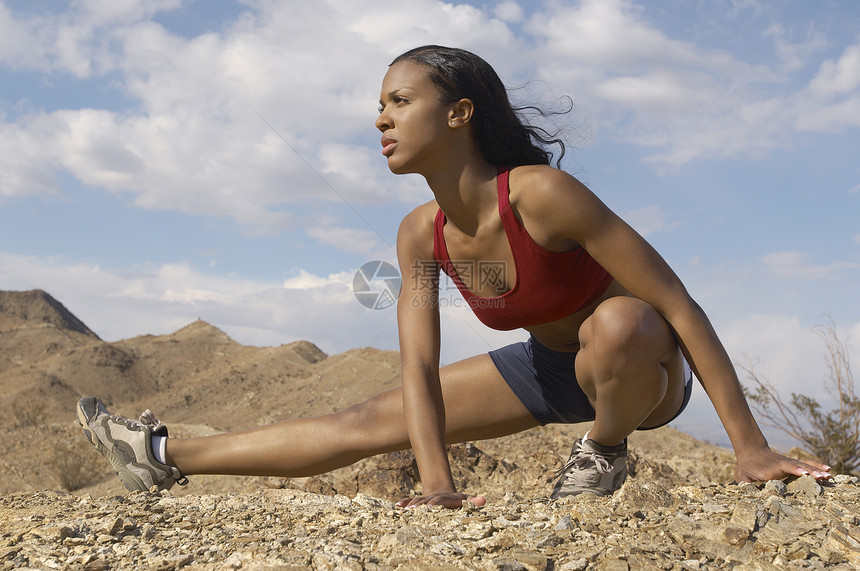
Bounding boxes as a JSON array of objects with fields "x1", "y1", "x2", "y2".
[{"x1": 78, "y1": 46, "x2": 829, "y2": 508}]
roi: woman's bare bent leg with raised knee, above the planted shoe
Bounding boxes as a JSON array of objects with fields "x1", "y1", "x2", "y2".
[{"x1": 576, "y1": 297, "x2": 685, "y2": 446}]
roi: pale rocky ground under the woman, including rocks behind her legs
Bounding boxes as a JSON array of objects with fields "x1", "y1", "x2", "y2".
[{"x1": 0, "y1": 420, "x2": 860, "y2": 570}]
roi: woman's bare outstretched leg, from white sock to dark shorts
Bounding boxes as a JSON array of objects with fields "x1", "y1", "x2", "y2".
[{"x1": 167, "y1": 355, "x2": 538, "y2": 477}]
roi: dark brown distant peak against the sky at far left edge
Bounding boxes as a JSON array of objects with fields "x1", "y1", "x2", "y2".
[{"x1": 0, "y1": 289, "x2": 101, "y2": 340}]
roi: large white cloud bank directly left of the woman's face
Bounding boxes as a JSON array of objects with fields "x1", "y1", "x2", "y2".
[{"x1": 0, "y1": 0, "x2": 490, "y2": 228}]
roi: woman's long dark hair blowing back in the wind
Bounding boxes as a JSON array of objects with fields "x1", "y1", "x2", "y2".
[{"x1": 390, "y1": 45, "x2": 570, "y2": 167}]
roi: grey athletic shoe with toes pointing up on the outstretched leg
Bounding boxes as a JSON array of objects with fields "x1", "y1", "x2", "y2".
[{"x1": 77, "y1": 397, "x2": 188, "y2": 492}]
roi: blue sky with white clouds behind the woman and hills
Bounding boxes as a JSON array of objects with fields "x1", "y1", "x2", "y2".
[{"x1": 0, "y1": 0, "x2": 860, "y2": 446}]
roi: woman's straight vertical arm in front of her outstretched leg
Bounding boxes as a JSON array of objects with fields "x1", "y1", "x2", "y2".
[{"x1": 397, "y1": 203, "x2": 483, "y2": 508}]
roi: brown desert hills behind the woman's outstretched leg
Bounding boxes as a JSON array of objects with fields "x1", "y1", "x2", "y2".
[{"x1": 0, "y1": 291, "x2": 399, "y2": 492}]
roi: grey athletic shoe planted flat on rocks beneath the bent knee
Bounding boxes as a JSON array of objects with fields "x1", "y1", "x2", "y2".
[{"x1": 551, "y1": 433, "x2": 627, "y2": 500}]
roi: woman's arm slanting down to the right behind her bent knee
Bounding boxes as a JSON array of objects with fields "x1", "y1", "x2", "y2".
[{"x1": 523, "y1": 169, "x2": 827, "y2": 481}]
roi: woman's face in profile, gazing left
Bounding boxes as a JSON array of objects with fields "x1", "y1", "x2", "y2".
[{"x1": 376, "y1": 61, "x2": 450, "y2": 174}]
